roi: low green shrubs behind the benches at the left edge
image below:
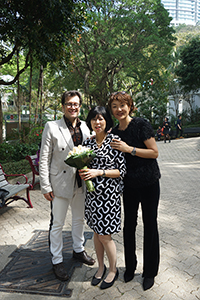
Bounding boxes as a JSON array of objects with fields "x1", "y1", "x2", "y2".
[{"x1": 0, "y1": 142, "x2": 38, "y2": 163}]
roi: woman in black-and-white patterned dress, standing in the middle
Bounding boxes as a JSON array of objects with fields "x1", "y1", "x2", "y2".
[{"x1": 79, "y1": 106, "x2": 126, "y2": 289}]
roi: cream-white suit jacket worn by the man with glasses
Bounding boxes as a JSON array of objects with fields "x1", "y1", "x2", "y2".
[{"x1": 39, "y1": 117, "x2": 90, "y2": 198}]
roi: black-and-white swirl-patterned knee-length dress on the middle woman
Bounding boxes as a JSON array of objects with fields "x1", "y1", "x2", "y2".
[{"x1": 83, "y1": 133, "x2": 126, "y2": 235}]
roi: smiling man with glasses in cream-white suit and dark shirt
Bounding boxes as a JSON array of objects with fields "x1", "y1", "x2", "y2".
[{"x1": 40, "y1": 91, "x2": 95, "y2": 280}]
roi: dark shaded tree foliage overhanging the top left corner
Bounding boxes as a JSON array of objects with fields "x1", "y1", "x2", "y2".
[{"x1": 0, "y1": 0, "x2": 84, "y2": 85}]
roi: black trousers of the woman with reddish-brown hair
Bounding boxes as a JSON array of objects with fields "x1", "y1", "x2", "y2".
[{"x1": 123, "y1": 180, "x2": 160, "y2": 277}]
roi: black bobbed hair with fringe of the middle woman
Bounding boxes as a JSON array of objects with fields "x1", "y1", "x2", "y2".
[{"x1": 86, "y1": 106, "x2": 113, "y2": 132}]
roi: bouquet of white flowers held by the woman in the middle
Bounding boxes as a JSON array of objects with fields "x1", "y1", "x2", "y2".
[{"x1": 65, "y1": 145, "x2": 96, "y2": 192}]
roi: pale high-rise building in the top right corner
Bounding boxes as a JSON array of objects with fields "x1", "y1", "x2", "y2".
[{"x1": 161, "y1": 0, "x2": 200, "y2": 26}]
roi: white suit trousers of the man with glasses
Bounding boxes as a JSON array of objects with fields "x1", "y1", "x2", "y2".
[{"x1": 49, "y1": 189, "x2": 85, "y2": 264}]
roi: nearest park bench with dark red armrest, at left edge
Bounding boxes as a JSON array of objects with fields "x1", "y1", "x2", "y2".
[{"x1": 0, "y1": 164, "x2": 33, "y2": 208}]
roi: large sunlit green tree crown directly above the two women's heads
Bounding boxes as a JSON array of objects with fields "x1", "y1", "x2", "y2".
[{"x1": 68, "y1": 0, "x2": 174, "y2": 105}]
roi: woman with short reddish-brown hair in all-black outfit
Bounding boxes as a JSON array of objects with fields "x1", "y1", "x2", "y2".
[{"x1": 108, "y1": 92, "x2": 161, "y2": 290}]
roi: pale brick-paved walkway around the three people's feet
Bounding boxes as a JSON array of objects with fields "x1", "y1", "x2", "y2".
[{"x1": 0, "y1": 137, "x2": 200, "y2": 300}]
